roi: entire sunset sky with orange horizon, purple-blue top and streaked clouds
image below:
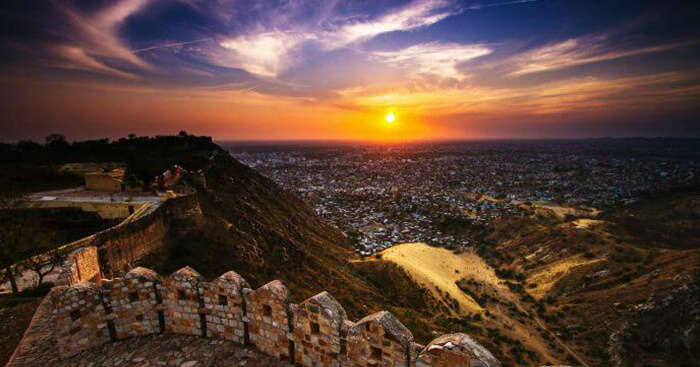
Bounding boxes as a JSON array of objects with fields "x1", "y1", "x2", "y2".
[{"x1": 0, "y1": 0, "x2": 700, "y2": 141}]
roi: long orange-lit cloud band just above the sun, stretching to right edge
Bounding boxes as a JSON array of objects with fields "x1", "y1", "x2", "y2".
[{"x1": 336, "y1": 72, "x2": 700, "y2": 116}]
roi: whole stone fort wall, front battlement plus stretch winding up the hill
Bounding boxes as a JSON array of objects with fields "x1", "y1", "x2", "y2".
[{"x1": 8, "y1": 195, "x2": 500, "y2": 367}]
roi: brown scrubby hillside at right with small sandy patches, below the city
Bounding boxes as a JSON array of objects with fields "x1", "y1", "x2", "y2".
[{"x1": 464, "y1": 190, "x2": 700, "y2": 366}]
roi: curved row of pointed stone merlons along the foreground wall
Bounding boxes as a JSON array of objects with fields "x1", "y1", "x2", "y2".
[{"x1": 49, "y1": 267, "x2": 500, "y2": 367}]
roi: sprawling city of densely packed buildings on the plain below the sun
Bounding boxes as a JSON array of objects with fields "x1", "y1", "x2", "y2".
[{"x1": 231, "y1": 139, "x2": 700, "y2": 256}]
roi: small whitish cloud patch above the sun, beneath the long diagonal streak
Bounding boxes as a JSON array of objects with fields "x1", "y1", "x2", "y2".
[{"x1": 374, "y1": 42, "x2": 492, "y2": 79}]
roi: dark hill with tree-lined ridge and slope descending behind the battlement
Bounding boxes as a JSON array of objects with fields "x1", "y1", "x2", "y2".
[{"x1": 0, "y1": 133, "x2": 442, "y2": 366}]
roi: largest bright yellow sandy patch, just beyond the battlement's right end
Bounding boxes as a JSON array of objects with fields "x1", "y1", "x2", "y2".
[{"x1": 381, "y1": 243, "x2": 499, "y2": 313}]
